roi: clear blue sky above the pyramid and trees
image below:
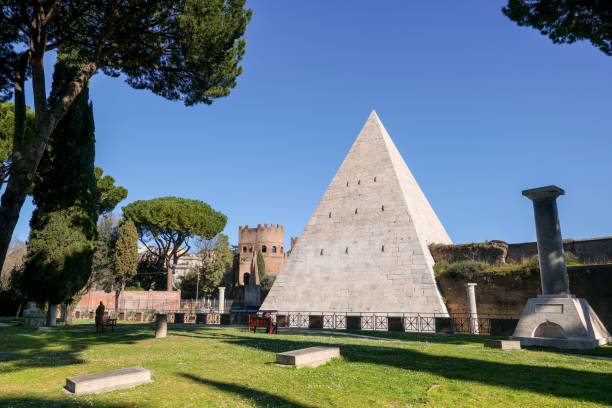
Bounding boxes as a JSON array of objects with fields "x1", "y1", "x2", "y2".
[{"x1": 9, "y1": 0, "x2": 612, "y2": 247}]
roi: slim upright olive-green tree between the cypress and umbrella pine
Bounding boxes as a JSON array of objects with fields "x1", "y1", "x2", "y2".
[{"x1": 114, "y1": 220, "x2": 138, "y2": 290}]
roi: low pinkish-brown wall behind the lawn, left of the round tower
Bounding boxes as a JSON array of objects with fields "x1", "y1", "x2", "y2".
[{"x1": 76, "y1": 290, "x2": 181, "y2": 311}]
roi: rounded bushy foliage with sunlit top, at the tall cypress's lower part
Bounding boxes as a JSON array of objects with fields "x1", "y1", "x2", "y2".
[{"x1": 23, "y1": 207, "x2": 94, "y2": 304}]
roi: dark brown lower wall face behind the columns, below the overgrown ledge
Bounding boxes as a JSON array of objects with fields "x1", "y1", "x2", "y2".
[{"x1": 436, "y1": 264, "x2": 612, "y2": 332}]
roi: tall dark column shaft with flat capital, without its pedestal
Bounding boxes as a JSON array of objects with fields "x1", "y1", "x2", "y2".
[{"x1": 523, "y1": 186, "x2": 570, "y2": 296}]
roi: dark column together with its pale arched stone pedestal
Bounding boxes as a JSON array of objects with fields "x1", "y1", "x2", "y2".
[{"x1": 510, "y1": 186, "x2": 612, "y2": 349}]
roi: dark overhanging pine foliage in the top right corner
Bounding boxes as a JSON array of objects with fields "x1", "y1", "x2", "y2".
[{"x1": 502, "y1": 0, "x2": 612, "y2": 55}]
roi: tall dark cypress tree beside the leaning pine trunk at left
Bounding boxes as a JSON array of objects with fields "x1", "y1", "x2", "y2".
[{"x1": 24, "y1": 50, "x2": 99, "y2": 318}]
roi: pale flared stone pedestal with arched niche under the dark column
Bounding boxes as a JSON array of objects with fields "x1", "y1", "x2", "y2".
[{"x1": 510, "y1": 295, "x2": 612, "y2": 349}]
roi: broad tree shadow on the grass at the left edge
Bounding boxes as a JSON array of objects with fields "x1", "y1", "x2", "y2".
[{"x1": 0, "y1": 325, "x2": 154, "y2": 372}]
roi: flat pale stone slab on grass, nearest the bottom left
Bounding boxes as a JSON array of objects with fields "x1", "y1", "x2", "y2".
[{"x1": 65, "y1": 367, "x2": 151, "y2": 395}]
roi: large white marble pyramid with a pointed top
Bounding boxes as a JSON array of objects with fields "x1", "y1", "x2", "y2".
[{"x1": 261, "y1": 111, "x2": 452, "y2": 313}]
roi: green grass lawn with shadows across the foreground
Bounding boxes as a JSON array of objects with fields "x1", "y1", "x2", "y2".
[{"x1": 0, "y1": 320, "x2": 612, "y2": 408}]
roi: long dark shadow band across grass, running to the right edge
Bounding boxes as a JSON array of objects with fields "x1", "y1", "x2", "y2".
[{"x1": 202, "y1": 333, "x2": 612, "y2": 404}]
